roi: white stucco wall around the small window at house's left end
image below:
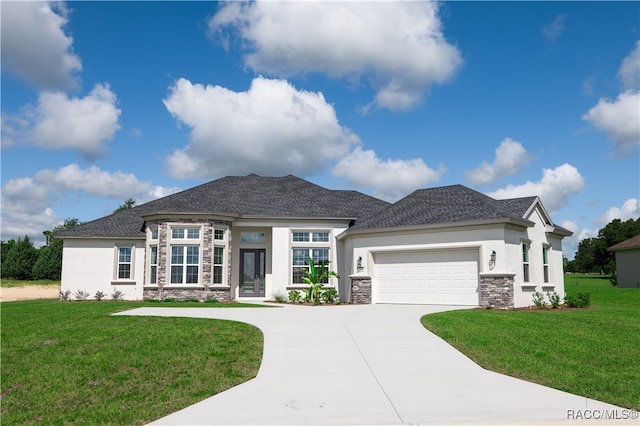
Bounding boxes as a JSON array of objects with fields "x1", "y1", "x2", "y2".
[{"x1": 60, "y1": 239, "x2": 145, "y2": 300}]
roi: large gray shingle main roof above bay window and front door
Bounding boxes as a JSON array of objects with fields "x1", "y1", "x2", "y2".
[{"x1": 56, "y1": 174, "x2": 389, "y2": 238}]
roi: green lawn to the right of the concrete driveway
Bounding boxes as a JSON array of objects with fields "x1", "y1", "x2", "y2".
[{"x1": 422, "y1": 275, "x2": 640, "y2": 409}]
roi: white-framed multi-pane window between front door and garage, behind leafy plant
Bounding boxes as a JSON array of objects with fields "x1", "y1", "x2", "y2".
[{"x1": 291, "y1": 231, "x2": 330, "y2": 284}]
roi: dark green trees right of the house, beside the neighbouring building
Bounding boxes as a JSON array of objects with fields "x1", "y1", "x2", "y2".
[{"x1": 564, "y1": 218, "x2": 640, "y2": 275}]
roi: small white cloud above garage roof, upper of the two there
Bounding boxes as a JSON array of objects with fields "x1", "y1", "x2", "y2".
[{"x1": 466, "y1": 138, "x2": 531, "y2": 186}]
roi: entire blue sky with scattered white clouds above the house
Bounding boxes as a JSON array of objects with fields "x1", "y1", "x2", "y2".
[{"x1": 0, "y1": 1, "x2": 640, "y2": 257}]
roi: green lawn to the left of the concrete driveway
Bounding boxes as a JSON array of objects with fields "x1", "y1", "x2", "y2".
[{"x1": 0, "y1": 300, "x2": 263, "y2": 425}]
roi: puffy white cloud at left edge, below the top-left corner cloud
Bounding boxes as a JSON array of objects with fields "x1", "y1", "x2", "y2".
[{"x1": 2, "y1": 84, "x2": 121, "y2": 160}]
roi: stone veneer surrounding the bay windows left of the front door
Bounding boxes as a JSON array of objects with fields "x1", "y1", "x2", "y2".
[{"x1": 142, "y1": 219, "x2": 232, "y2": 301}]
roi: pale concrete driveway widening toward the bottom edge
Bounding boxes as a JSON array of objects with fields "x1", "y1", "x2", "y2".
[{"x1": 119, "y1": 305, "x2": 637, "y2": 425}]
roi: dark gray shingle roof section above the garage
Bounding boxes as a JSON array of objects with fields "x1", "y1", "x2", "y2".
[{"x1": 350, "y1": 185, "x2": 536, "y2": 231}]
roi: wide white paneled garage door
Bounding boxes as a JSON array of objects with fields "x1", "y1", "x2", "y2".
[{"x1": 372, "y1": 250, "x2": 479, "y2": 306}]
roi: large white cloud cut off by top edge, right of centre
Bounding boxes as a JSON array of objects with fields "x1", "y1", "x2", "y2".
[{"x1": 209, "y1": 1, "x2": 462, "y2": 111}]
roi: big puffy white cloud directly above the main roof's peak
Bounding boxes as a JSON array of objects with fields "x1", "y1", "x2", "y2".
[{"x1": 164, "y1": 77, "x2": 360, "y2": 178}]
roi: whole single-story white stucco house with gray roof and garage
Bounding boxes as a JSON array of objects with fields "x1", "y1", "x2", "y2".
[{"x1": 56, "y1": 174, "x2": 571, "y2": 308}]
